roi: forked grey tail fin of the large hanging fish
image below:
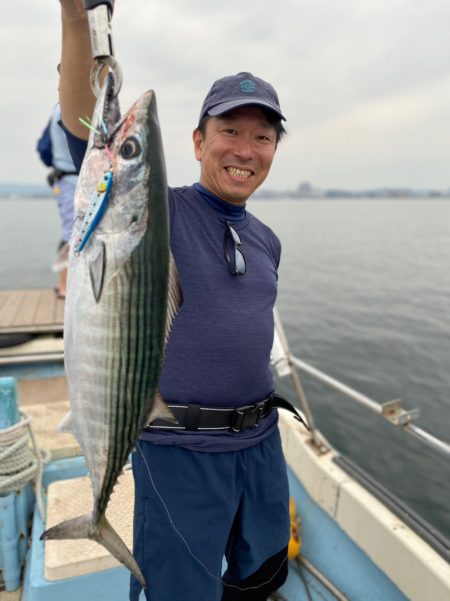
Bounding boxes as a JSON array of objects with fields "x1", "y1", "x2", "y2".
[{"x1": 41, "y1": 513, "x2": 147, "y2": 588}]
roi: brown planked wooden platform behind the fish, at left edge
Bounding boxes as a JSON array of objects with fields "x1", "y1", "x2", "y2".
[{"x1": 0, "y1": 289, "x2": 64, "y2": 334}]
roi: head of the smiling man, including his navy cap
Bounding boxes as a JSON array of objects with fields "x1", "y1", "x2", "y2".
[{"x1": 193, "y1": 73, "x2": 284, "y2": 204}]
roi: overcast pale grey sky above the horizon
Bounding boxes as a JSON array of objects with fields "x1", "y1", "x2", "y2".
[{"x1": 0, "y1": 0, "x2": 450, "y2": 189}]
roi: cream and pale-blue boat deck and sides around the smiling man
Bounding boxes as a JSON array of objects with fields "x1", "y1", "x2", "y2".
[{"x1": 0, "y1": 290, "x2": 450, "y2": 601}]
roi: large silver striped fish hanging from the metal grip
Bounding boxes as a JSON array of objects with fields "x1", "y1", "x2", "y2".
[{"x1": 41, "y1": 78, "x2": 181, "y2": 586}]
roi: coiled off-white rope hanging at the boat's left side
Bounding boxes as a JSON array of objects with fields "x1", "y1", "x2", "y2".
[{"x1": 0, "y1": 411, "x2": 48, "y2": 517}]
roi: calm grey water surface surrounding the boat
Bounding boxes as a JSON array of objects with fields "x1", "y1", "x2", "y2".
[{"x1": 0, "y1": 200, "x2": 450, "y2": 537}]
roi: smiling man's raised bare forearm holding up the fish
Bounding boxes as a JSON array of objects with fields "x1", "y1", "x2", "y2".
[{"x1": 59, "y1": 0, "x2": 95, "y2": 140}]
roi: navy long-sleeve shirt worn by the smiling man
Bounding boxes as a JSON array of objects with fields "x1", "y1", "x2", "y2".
[{"x1": 68, "y1": 133, "x2": 281, "y2": 452}]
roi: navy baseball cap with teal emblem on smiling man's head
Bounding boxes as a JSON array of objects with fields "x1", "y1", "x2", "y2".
[{"x1": 199, "y1": 72, "x2": 286, "y2": 121}]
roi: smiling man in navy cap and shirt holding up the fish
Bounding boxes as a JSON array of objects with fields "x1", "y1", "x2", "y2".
[{"x1": 60, "y1": 0, "x2": 289, "y2": 601}]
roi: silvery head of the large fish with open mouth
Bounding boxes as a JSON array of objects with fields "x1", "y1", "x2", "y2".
[{"x1": 74, "y1": 81, "x2": 167, "y2": 258}]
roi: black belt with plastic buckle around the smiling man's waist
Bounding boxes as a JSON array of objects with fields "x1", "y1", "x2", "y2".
[{"x1": 146, "y1": 393, "x2": 309, "y2": 432}]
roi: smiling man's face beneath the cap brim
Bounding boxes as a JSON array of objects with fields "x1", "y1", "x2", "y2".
[{"x1": 193, "y1": 106, "x2": 276, "y2": 205}]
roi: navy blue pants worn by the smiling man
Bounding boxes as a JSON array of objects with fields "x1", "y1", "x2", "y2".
[{"x1": 130, "y1": 429, "x2": 290, "y2": 601}]
